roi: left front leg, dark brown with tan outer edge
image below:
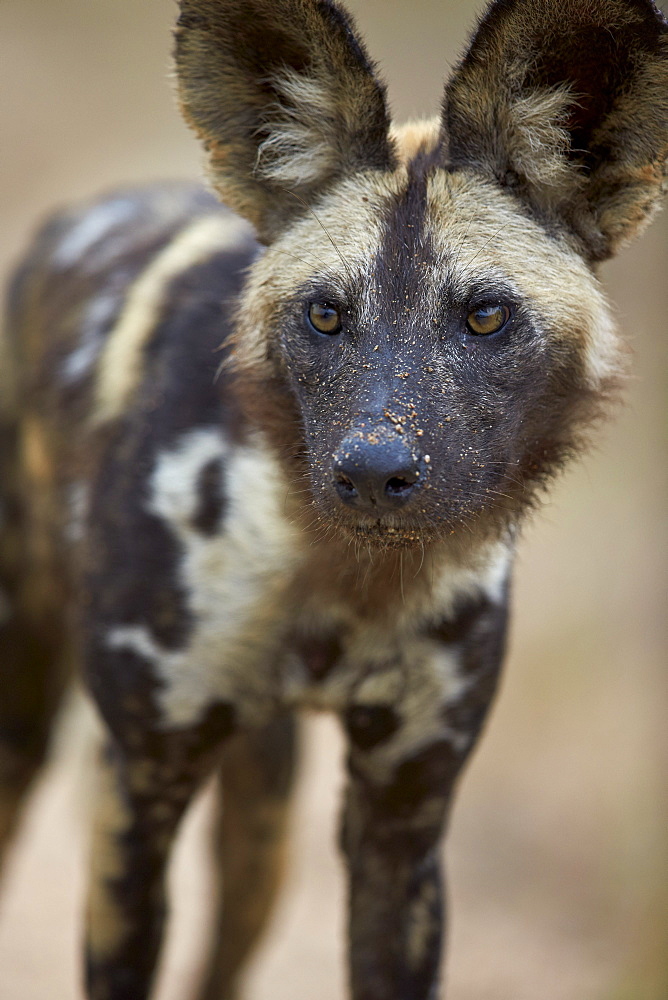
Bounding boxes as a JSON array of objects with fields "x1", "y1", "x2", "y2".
[{"x1": 86, "y1": 705, "x2": 233, "y2": 1000}]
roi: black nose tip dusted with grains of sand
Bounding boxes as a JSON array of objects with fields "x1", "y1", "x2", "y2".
[{"x1": 332, "y1": 432, "x2": 420, "y2": 514}]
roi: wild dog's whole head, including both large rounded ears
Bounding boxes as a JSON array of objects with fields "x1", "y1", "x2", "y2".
[{"x1": 177, "y1": 0, "x2": 668, "y2": 545}]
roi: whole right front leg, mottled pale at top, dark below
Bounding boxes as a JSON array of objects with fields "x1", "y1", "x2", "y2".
[{"x1": 342, "y1": 594, "x2": 506, "y2": 1000}]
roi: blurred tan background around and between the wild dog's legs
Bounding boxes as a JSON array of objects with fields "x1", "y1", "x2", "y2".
[{"x1": 0, "y1": 0, "x2": 668, "y2": 1000}]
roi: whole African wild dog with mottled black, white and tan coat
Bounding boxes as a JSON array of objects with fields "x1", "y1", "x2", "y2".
[{"x1": 0, "y1": 0, "x2": 668, "y2": 1000}]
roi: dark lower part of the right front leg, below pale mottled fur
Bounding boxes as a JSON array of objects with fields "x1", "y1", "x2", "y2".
[{"x1": 343, "y1": 740, "x2": 459, "y2": 1000}]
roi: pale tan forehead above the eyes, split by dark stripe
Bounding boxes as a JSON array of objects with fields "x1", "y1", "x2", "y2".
[{"x1": 268, "y1": 157, "x2": 594, "y2": 311}]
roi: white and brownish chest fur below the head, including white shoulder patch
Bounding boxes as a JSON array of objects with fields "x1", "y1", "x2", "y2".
[{"x1": 105, "y1": 427, "x2": 506, "y2": 726}]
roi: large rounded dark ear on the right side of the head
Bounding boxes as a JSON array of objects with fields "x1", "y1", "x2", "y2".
[{"x1": 443, "y1": 0, "x2": 668, "y2": 261}]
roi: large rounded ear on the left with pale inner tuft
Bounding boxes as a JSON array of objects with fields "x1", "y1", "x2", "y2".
[{"x1": 175, "y1": 0, "x2": 393, "y2": 241}]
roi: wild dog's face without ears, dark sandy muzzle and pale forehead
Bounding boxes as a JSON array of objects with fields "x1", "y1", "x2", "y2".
[{"x1": 240, "y1": 152, "x2": 616, "y2": 544}]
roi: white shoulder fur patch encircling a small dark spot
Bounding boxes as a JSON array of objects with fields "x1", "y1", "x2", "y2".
[{"x1": 139, "y1": 427, "x2": 300, "y2": 725}]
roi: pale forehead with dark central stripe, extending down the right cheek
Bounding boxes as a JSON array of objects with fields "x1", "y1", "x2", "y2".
[{"x1": 253, "y1": 154, "x2": 617, "y2": 381}]
